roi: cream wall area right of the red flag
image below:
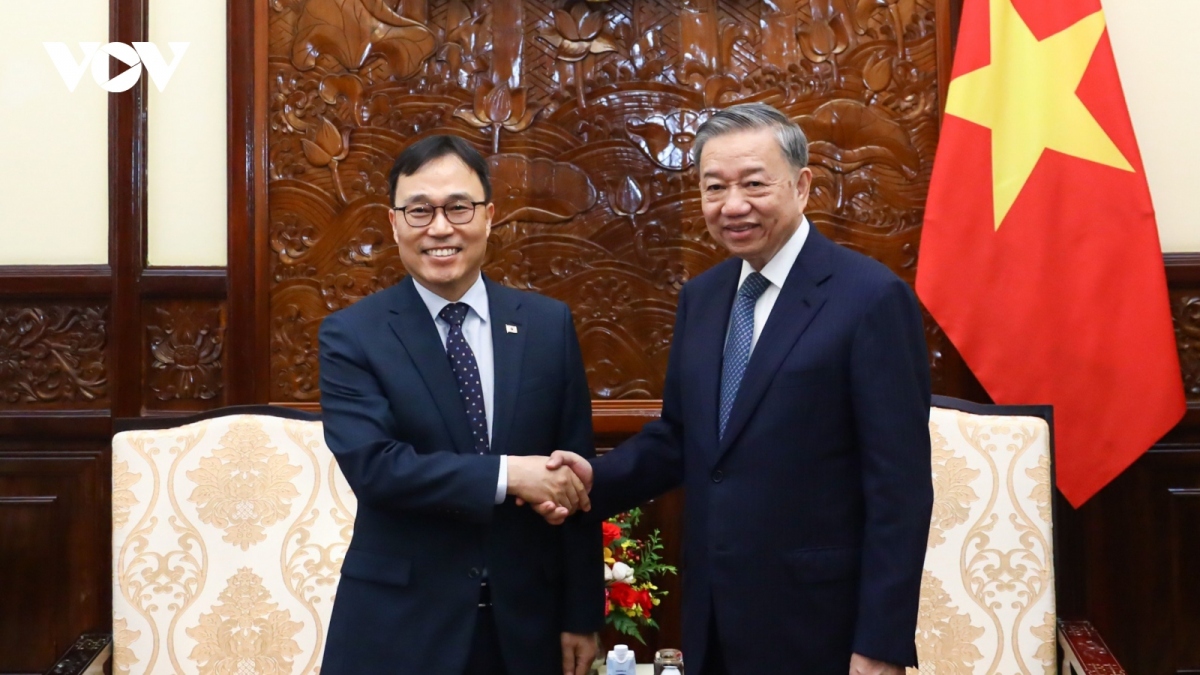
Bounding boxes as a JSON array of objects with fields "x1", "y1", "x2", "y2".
[{"x1": 1104, "y1": 0, "x2": 1200, "y2": 252}]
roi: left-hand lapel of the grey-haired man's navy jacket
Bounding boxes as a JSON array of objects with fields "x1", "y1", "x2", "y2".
[{"x1": 688, "y1": 258, "x2": 742, "y2": 454}]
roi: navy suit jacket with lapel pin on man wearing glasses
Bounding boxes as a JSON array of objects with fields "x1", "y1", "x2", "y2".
[{"x1": 320, "y1": 277, "x2": 604, "y2": 675}]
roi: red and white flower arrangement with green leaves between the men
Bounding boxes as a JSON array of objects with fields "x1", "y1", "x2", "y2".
[{"x1": 602, "y1": 508, "x2": 676, "y2": 645}]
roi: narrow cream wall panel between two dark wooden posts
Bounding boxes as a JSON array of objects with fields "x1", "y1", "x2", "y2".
[{"x1": 145, "y1": 0, "x2": 228, "y2": 267}]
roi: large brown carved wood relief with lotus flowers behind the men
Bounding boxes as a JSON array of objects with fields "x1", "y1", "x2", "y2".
[{"x1": 268, "y1": 0, "x2": 947, "y2": 401}]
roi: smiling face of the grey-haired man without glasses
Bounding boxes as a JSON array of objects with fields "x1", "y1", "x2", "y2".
[{"x1": 700, "y1": 129, "x2": 812, "y2": 270}]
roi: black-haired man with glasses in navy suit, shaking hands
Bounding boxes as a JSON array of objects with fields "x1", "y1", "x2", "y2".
[{"x1": 320, "y1": 136, "x2": 604, "y2": 675}]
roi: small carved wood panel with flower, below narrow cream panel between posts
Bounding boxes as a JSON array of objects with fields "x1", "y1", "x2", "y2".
[{"x1": 144, "y1": 300, "x2": 226, "y2": 407}]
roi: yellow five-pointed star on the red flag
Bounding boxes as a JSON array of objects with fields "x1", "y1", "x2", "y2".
[{"x1": 946, "y1": 0, "x2": 1133, "y2": 229}]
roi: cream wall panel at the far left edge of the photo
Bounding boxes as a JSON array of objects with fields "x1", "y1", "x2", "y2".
[{"x1": 0, "y1": 0, "x2": 108, "y2": 264}]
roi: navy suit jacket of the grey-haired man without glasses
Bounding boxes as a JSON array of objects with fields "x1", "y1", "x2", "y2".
[{"x1": 592, "y1": 228, "x2": 934, "y2": 675}]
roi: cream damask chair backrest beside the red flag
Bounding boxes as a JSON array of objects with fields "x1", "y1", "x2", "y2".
[{"x1": 910, "y1": 398, "x2": 1056, "y2": 674}]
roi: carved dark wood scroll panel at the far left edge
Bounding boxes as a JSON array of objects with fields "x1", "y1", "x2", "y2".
[{"x1": 0, "y1": 305, "x2": 108, "y2": 410}]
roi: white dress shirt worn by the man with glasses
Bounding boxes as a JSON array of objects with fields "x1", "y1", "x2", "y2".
[{"x1": 413, "y1": 274, "x2": 509, "y2": 503}]
